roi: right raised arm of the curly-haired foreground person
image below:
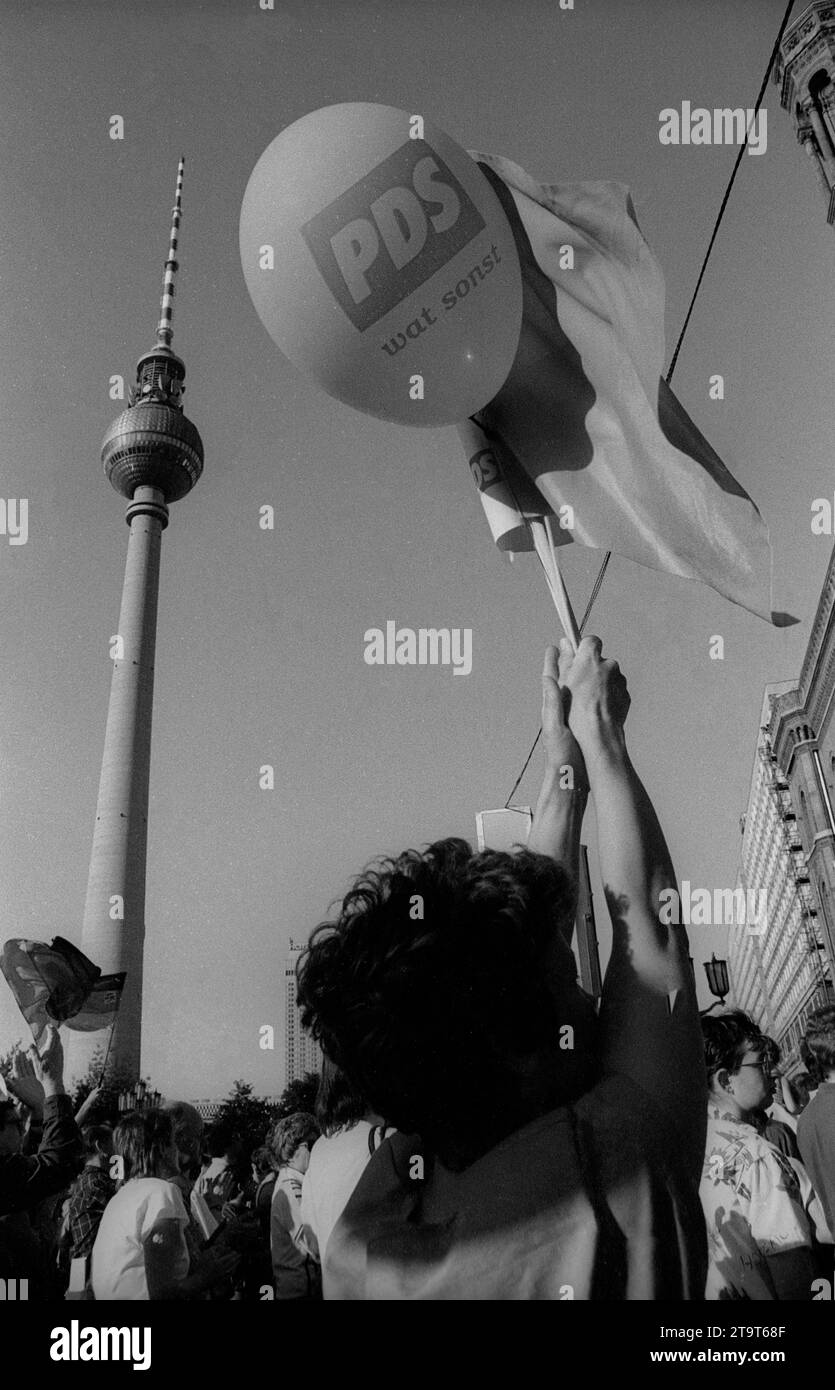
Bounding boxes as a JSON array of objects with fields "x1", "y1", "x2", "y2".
[{"x1": 560, "y1": 637, "x2": 706, "y2": 1163}]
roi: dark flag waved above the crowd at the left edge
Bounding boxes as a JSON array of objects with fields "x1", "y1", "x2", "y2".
[{"x1": 0, "y1": 937, "x2": 125, "y2": 1045}]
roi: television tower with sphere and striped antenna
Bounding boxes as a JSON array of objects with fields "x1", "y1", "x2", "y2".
[{"x1": 68, "y1": 158, "x2": 203, "y2": 1080}]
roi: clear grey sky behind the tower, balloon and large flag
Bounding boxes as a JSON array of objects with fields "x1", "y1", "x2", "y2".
[{"x1": 0, "y1": 0, "x2": 835, "y2": 1097}]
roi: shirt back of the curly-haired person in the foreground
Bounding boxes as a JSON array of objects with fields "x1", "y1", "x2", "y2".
[{"x1": 324, "y1": 1076, "x2": 707, "y2": 1302}]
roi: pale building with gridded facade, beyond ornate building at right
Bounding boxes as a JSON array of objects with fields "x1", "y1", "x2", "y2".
[{"x1": 728, "y1": 681, "x2": 829, "y2": 1068}]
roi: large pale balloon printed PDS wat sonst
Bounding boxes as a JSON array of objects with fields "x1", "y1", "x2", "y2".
[{"x1": 240, "y1": 101, "x2": 522, "y2": 425}]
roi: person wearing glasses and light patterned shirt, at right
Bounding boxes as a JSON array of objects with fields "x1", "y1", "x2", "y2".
[{"x1": 699, "y1": 1009, "x2": 825, "y2": 1301}]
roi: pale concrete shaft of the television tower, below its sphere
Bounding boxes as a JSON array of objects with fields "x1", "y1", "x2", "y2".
[{"x1": 72, "y1": 488, "x2": 168, "y2": 1079}]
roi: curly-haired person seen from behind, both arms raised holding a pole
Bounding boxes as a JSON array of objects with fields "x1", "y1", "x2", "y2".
[{"x1": 299, "y1": 637, "x2": 706, "y2": 1300}]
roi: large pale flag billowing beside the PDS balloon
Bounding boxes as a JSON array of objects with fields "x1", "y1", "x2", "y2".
[{"x1": 458, "y1": 153, "x2": 795, "y2": 627}]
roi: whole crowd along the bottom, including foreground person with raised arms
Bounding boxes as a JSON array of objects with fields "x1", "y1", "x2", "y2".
[{"x1": 0, "y1": 638, "x2": 835, "y2": 1301}]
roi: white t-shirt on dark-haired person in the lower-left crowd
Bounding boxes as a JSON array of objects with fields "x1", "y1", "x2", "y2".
[{"x1": 90, "y1": 1177, "x2": 189, "y2": 1301}]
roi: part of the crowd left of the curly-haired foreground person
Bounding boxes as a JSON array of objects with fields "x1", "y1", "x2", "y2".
[{"x1": 0, "y1": 1029, "x2": 389, "y2": 1301}]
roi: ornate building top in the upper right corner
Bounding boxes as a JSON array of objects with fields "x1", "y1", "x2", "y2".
[{"x1": 774, "y1": 0, "x2": 835, "y2": 224}]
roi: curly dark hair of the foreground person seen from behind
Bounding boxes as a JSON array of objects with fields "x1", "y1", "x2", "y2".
[{"x1": 297, "y1": 840, "x2": 579, "y2": 1166}]
